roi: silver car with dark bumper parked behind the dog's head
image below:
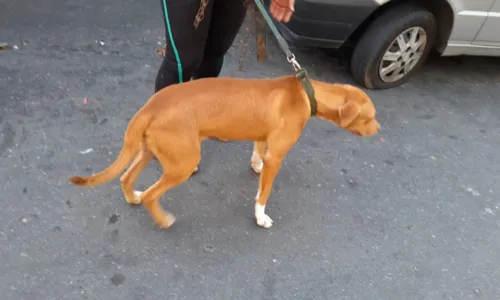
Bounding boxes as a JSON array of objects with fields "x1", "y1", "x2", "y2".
[{"x1": 272, "y1": 0, "x2": 500, "y2": 89}]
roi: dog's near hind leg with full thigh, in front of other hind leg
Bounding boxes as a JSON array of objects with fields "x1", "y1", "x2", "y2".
[{"x1": 141, "y1": 131, "x2": 201, "y2": 228}]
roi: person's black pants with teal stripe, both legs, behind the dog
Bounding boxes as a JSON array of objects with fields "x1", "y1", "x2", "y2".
[{"x1": 155, "y1": 0, "x2": 246, "y2": 92}]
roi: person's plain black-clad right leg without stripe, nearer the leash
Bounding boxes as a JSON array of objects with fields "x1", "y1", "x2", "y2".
[{"x1": 193, "y1": 0, "x2": 247, "y2": 79}]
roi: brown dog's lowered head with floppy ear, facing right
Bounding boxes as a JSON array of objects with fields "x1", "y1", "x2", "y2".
[{"x1": 318, "y1": 84, "x2": 380, "y2": 137}]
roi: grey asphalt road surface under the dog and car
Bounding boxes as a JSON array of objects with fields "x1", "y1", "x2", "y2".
[{"x1": 0, "y1": 0, "x2": 500, "y2": 300}]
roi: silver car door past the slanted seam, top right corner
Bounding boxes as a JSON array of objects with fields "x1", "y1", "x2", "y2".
[{"x1": 473, "y1": 0, "x2": 500, "y2": 47}]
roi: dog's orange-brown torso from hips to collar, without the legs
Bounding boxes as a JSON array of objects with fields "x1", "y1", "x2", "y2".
[{"x1": 144, "y1": 77, "x2": 307, "y2": 140}]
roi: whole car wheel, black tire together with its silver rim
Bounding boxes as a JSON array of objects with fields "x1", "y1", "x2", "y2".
[{"x1": 351, "y1": 4, "x2": 437, "y2": 89}]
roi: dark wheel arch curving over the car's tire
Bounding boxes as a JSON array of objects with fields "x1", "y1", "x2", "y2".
[{"x1": 345, "y1": 0, "x2": 455, "y2": 53}]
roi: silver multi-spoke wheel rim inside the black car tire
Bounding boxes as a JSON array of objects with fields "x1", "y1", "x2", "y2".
[{"x1": 379, "y1": 26, "x2": 427, "y2": 83}]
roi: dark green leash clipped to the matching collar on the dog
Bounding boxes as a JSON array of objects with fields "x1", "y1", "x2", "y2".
[{"x1": 254, "y1": 0, "x2": 318, "y2": 117}]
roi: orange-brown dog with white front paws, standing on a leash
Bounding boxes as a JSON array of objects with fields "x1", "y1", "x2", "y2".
[{"x1": 70, "y1": 76, "x2": 380, "y2": 228}]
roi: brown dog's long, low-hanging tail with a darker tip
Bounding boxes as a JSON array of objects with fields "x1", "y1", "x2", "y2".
[{"x1": 69, "y1": 111, "x2": 151, "y2": 187}]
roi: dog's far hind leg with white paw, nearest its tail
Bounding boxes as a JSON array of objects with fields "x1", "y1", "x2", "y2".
[{"x1": 120, "y1": 143, "x2": 153, "y2": 204}]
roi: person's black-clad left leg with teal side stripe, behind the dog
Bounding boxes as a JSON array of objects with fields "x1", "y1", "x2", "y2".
[{"x1": 155, "y1": 0, "x2": 214, "y2": 92}]
